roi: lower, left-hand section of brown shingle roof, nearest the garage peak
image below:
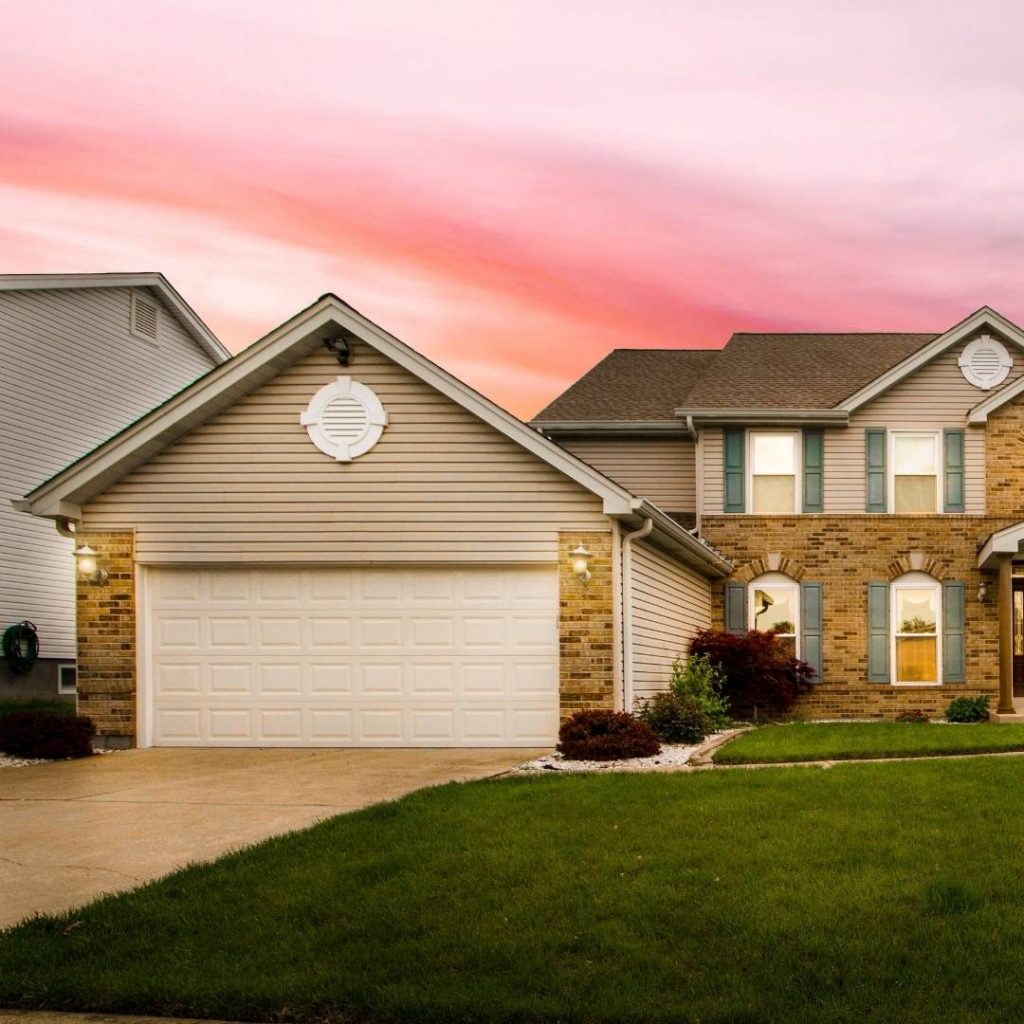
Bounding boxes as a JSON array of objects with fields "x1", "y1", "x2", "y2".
[{"x1": 531, "y1": 348, "x2": 721, "y2": 425}]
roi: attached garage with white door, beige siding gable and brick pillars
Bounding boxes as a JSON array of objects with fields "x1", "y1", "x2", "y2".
[{"x1": 19, "y1": 296, "x2": 731, "y2": 746}]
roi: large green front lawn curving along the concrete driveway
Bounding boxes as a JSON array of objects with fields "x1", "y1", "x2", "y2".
[{"x1": 9, "y1": 759, "x2": 1024, "y2": 1024}]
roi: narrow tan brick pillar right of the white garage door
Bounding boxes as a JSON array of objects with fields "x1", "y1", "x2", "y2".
[{"x1": 558, "y1": 532, "x2": 615, "y2": 721}]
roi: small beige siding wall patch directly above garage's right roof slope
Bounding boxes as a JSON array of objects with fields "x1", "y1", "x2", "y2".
[{"x1": 559, "y1": 437, "x2": 696, "y2": 512}]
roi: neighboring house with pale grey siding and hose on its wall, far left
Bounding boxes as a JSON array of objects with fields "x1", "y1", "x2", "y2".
[{"x1": 0, "y1": 273, "x2": 229, "y2": 699}]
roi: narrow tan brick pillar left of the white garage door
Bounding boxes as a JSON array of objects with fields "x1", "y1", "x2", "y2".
[{"x1": 76, "y1": 531, "x2": 135, "y2": 746}]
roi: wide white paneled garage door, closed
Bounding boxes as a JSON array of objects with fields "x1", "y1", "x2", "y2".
[{"x1": 142, "y1": 567, "x2": 558, "y2": 746}]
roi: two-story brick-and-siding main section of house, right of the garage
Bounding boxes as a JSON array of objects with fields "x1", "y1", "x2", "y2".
[{"x1": 534, "y1": 308, "x2": 1024, "y2": 717}]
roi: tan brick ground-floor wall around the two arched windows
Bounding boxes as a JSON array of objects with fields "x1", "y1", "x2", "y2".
[{"x1": 701, "y1": 516, "x2": 1003, "y2": 718}]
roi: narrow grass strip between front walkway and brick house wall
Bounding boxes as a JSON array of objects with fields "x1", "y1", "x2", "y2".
[{"x1": 715, "y1": 722, "x2": 1024, "y2": 765}]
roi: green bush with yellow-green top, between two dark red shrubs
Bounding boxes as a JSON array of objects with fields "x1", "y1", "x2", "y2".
[{"x1": 636, "y1": 654, "x2": 729, "y2": 743}]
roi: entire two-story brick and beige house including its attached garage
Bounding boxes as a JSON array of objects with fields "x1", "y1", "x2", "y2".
[{"x1": 23, "y1": 295, "x2": 1024, "y2": 746}]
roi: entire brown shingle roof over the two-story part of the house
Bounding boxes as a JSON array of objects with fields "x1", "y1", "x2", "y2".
[{"x1": 536, "y1": 334, "x2": 938, "y2": 422}]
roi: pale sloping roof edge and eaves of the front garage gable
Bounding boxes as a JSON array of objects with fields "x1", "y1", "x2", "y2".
[{"x1": 17, "y1": 294, "x2": 731, "y2": 575}]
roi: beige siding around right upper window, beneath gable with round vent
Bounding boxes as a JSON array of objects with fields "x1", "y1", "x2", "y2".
[{"x1": 824, "y1": 343, "x2": 1024, "y2": 514}]
